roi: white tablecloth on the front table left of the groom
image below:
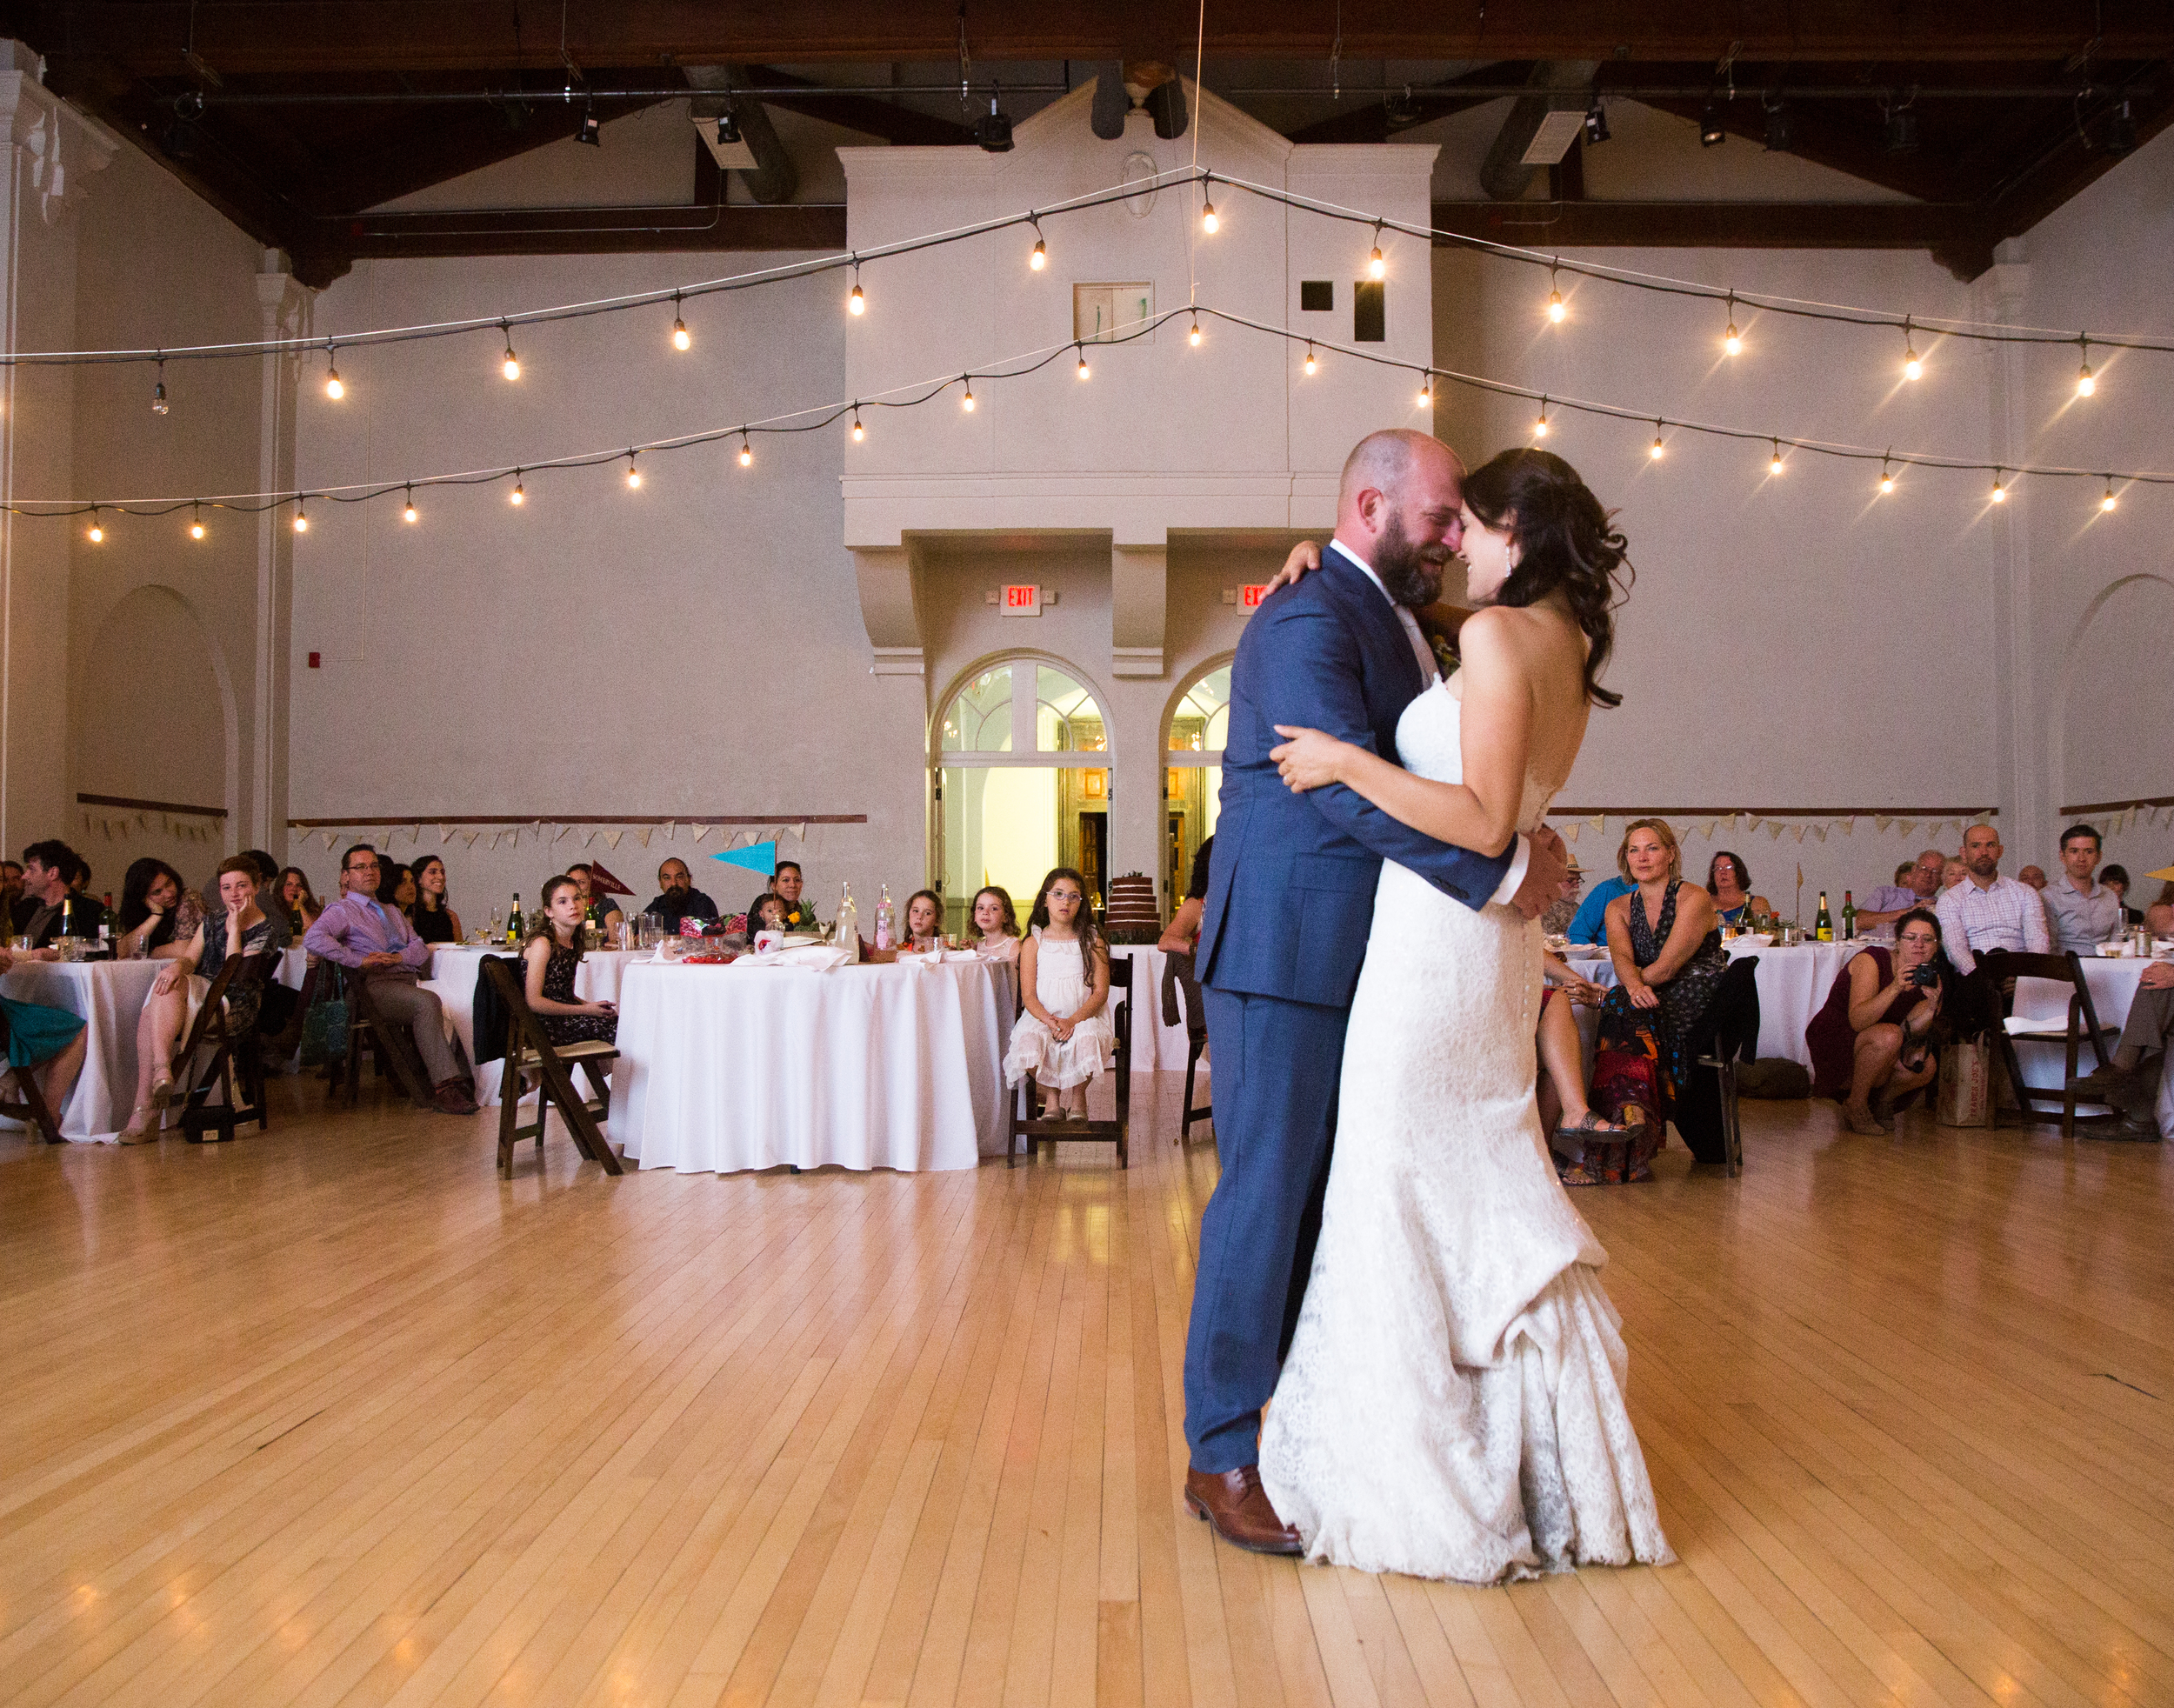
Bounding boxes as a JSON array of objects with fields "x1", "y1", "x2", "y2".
[{"x1": 611, "y1": 958, "x2": 1017, "y2": 1173}]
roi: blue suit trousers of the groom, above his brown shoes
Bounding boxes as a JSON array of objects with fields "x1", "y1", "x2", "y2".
[{"x1": 1185, "y1": 989, "x2": 1350, "y2": 1473}]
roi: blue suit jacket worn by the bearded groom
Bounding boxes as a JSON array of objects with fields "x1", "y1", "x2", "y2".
[{"x1": 1194, "y1": 548, "x2": 1516, "y2": 1008}]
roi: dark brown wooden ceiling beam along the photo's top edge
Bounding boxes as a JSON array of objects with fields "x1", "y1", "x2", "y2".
[{"x1": 11, "y1": 0, "x2": 2174, "y2": 76}]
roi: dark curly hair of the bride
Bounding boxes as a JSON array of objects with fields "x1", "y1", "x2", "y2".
[{"x1": 1465, "y1": 445, "x2": 1637, "y2": 706}]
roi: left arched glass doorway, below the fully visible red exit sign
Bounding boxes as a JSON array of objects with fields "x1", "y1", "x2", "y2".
[{"x1": 933, "y1": 658, "x2": 1109, "y2": 932}]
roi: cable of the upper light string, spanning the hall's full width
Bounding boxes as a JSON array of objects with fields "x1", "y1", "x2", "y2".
[{"x1": 17, "y1": 163, "x2": 2174, "y2": 373}]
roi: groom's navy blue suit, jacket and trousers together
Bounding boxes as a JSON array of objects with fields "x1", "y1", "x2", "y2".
[{"x1": 1185, "y1": 545, "x2": 1511, "y2": 1473}]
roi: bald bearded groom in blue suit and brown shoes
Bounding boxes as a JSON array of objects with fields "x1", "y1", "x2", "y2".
[{"x1": 1185, "y1": 428, "x2": 1565, "y2": 1554}]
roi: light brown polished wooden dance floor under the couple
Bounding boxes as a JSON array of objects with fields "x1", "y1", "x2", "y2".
[{"x1": 0, "y1": 1076, "x2": 2174, "y2": 1708}]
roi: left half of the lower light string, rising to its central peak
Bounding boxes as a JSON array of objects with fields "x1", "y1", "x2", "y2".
[{"x1": 0, "y1": 309, "x2": 1209, "y2": 519}]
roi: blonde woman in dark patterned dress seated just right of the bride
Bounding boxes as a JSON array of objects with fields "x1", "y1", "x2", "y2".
[{"x1": 1591, "y1": 819, "x2": 1729, "y2": 1186}]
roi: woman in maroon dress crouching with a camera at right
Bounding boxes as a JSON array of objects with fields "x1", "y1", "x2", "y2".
[{"x1": 1804, "y1": 908, "x2": 1946, "y2": 1132}]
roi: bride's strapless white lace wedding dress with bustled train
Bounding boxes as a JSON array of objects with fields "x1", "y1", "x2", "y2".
[{"x1": 1261, "y1": 678, "x2": 1674, "y2": 1585}]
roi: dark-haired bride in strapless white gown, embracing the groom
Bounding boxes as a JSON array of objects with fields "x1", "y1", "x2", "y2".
[{"x1": 1261, "y1": 450, "x2": 1674, "y2": 1585}]
